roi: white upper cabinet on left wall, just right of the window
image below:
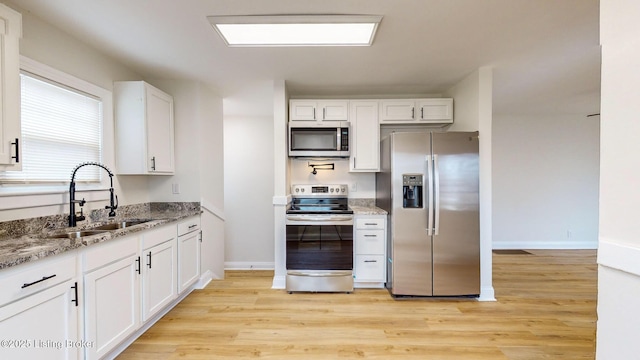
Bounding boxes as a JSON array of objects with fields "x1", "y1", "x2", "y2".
[{"x1": 114, "y1": 81, "x2": 175, "y2": 175}]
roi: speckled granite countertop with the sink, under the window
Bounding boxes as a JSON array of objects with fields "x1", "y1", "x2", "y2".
[{"x1": 0, "y1": 203, "x2": 202, "y2": 269}]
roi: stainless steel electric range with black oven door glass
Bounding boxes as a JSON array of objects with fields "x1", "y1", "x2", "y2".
[{"x1": 286, "y1": 185, "x2": 353, "y2": 293}]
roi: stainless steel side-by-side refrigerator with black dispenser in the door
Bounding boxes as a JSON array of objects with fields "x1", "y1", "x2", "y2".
[{"x1": 376, "y1": 132, "x2": 480, "y2": 296}]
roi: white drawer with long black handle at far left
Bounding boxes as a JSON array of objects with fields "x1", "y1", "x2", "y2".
[{"x1": 0, "y1": 252, "x2": 76, "y2": 306}]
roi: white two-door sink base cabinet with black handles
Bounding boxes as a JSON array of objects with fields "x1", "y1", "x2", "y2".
[{"x1": 83, "y1": 224, "x2": 178, "y2": 359}]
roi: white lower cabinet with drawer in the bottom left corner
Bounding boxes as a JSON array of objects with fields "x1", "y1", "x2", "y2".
[{"x1": 0, "y1": 253, "x2": 80, "y2": 360}]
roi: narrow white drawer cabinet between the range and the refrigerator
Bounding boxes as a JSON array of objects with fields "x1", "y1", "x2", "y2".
[{"x1": 353, "y1": 215, "x2": 387, "y2": 288}]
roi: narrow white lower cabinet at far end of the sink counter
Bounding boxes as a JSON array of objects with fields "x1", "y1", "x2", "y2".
[{"x1": 178, "y1": 216, "x2": 202, "y2": 292}]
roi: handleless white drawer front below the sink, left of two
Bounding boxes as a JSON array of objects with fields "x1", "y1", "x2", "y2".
[{"x1": 82, "y1": 235, "x2": 140, "y2": 273}]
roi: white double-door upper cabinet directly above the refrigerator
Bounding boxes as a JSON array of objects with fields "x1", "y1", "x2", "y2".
[{"x1": 380, "y1": 98, "x2": 453, "y2": 124}]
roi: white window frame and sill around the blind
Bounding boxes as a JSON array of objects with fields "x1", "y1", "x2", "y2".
[{"x1": 0, "y1": 56, "x2": 115, "y2": 211}]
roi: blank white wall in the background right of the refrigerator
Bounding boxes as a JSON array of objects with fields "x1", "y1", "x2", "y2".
[{"x1": 493, "y1": 115, "x2": 600, "y2": 249}]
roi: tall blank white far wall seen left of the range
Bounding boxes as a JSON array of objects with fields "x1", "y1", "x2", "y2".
[{"x1": 223, "y1": 81, "x2": 274, "y2": 269}]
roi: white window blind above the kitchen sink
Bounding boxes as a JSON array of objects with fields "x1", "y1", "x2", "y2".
[{"x1": 0, "y1": 73, "x2": 103, "y2": 183}]
